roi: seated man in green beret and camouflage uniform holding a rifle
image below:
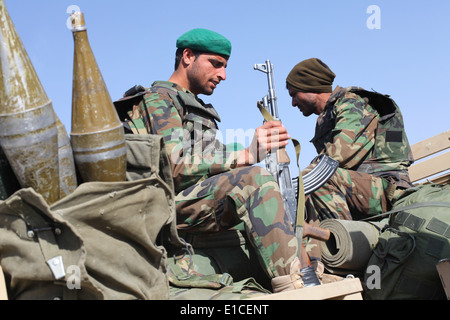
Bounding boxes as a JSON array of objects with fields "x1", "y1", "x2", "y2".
[{"x1": 121, "y1": 29, "x2": 303, "y2": 291}]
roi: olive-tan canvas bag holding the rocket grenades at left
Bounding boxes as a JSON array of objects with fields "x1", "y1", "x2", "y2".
[{"x1": 0, "y1": 135, "x2": 184, "y2": 299}]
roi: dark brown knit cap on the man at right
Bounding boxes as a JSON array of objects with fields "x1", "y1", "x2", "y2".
[{"x1": 286, "y1": 58, "x2": 336, "y2": 93}]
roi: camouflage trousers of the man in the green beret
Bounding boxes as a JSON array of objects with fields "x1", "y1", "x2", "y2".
[{"x1": 175, "y1": 166, "x2": 298, "y2": 278}]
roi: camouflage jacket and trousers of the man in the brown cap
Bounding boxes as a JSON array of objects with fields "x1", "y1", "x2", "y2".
[{"x1": 307, "y1": 87, "x2": 413, "y2": 220}]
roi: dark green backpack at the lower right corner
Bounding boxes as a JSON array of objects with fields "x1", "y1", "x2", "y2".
[{"x1": 364, "y1": 184, "x2": 450, "y2": 300}]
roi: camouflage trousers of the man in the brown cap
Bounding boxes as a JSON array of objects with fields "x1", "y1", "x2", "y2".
[{"x1": 306, "y1": 168, "x2": 401, "y2": 221}]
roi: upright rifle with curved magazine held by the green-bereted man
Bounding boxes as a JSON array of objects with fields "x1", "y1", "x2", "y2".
[{"x1": 254, "y1": 60, "x2": 336, "y2": 285}]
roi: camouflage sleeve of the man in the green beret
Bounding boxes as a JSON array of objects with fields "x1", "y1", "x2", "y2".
[{"x1": 140, "y1": 93, "x2": 238, "y2": 191}]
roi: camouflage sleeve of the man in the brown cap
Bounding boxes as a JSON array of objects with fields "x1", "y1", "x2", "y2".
[{"x1": 325, "y1": 93, "x2": 378, "y2": 169}]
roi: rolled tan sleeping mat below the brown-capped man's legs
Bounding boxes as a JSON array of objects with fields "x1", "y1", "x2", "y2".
[{"x1": 319, "y1": 219, "x2": 386, "y2": 275}]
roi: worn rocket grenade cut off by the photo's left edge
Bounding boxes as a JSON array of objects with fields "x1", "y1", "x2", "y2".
[{"x1": 0, "y1": 0, "x2": 60, "y2": 203}]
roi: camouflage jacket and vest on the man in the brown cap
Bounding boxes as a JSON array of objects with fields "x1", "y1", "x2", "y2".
[{"x1": 311, "y1": 87, "x2": 413, "y2": 188}]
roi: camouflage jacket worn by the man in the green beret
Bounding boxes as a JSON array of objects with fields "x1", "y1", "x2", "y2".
[{"x1": 123, "y1": 81, "x2": 238, "y2": 193}]
